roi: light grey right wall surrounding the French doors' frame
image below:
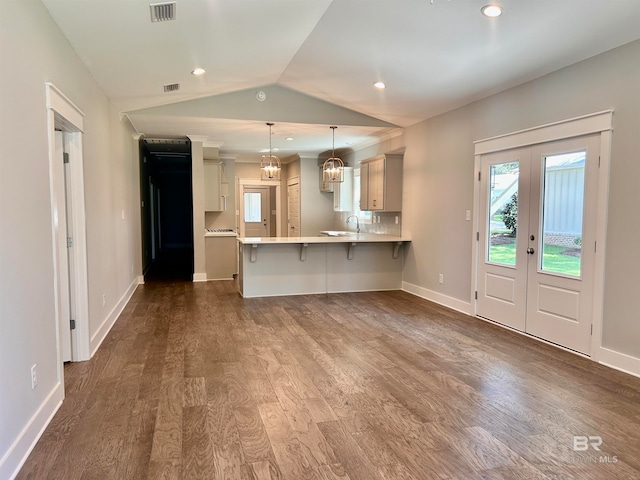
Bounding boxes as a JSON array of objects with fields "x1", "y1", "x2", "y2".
[{"x1": 403, "y1": 41, "x2": 640, "y2": 364}]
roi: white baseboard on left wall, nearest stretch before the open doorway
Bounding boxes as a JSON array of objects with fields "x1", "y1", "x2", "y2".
[{"x1": 0, "y1": 382, "x2": 64, "y2": 480}]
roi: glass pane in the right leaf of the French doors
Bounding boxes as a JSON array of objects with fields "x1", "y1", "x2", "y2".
[{"x1": 540, "y1": 151, "x2": 587, "y2": 277}]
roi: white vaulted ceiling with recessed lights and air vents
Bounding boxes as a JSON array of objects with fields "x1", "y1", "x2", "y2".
[{"x1": 42, "y1": 0, "x2": 640, "y2": 158}]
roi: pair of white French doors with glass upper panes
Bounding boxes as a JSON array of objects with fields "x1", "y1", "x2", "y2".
[{"x1": 476, "y1": 135, "x2": 600, "y2": 354}]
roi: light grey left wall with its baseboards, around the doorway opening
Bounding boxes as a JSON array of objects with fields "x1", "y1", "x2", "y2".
[{"x1": 0, "y1": 0, "x2": 140, "y2": 478}]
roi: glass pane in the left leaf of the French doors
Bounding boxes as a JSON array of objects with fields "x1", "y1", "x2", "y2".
[{"x1": 487, "y1": 162, "x2": 520, "y2": 265}]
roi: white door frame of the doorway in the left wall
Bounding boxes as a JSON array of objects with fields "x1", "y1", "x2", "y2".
[{"x1": 45, "y1": 82, "x2": 91, "y2": 362}]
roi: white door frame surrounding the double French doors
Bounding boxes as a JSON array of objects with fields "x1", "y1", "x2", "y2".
[{"x1": 470, "y1": 110, "x2": 613, "y2": 361}]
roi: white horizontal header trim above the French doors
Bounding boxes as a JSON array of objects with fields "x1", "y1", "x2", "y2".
[{"x1": 473, "y1": 110, "x2": 613, "y2": 155}]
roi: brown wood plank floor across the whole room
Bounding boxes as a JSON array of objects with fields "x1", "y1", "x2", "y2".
[{"x1": 18, "y1": 281, "x2": 640, "y2": 480}]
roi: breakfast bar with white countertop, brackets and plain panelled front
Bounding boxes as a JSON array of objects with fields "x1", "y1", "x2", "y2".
[{"x1": 238, "y1": 232, "x2": 410, "y2": 298}]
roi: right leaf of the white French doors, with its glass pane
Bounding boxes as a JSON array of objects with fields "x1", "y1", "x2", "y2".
[{"x1": 526, "y1": 136, "x2": 600, "y2": 354}]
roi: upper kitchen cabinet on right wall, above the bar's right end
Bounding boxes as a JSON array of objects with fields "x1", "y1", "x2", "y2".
[{"x1": 360, "y1": 155, "x2": 402, "y2": 212}]
